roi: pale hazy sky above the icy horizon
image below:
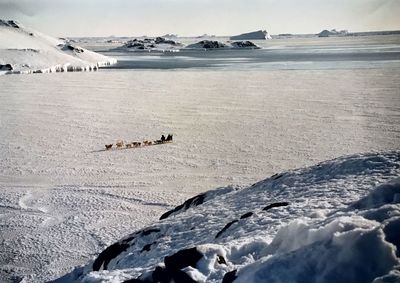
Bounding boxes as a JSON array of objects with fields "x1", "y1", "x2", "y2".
[{"x1": 0, "y1": 0, "x2": 400, "y2": 36}]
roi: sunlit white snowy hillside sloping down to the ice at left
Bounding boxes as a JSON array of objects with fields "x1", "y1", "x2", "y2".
[{"x1": 0, "y1": 20, "x2": 116, "y2": 74}]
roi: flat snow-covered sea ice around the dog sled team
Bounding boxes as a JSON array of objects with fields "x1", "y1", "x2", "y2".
[{"x1": 0, "y1": 68, "x2": 400, "y2": 282}]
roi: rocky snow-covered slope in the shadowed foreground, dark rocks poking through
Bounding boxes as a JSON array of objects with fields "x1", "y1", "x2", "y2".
[{"x1": 55, "y1": 151, "x2": 400, "y2": 283}]
